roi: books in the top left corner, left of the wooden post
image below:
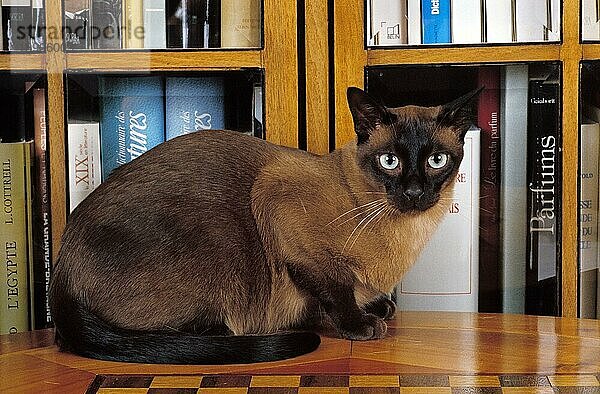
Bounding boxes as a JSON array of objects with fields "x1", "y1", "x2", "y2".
[{"x1": 0, "y1": 0, "x2": 46, "y2": 51}]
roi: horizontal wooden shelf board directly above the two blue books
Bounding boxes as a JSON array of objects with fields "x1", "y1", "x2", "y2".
[{"x1": 65, "y1": 50, "x2": 262, "y2": 71}]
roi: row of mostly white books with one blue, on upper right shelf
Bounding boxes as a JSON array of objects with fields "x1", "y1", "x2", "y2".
[{"x1": 367, "y1": 0, "x2": 561, "y2": 47}]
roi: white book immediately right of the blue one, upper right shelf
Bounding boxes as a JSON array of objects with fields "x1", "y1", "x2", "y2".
[{"x1": 450, "y1": 0, "x2": 481, "y2": 44}]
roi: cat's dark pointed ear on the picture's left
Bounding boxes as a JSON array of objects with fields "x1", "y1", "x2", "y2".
[{"x1": 346, "y1": 87, "x2": 390, "y2": 144}]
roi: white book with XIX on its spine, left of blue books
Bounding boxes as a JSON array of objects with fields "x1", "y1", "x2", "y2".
[{"x1": 67, "y1": 123, "x2": 102, "y2": 212}]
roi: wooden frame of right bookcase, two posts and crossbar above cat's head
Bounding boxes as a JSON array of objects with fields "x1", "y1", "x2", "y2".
[{"x1": 333, "y1": 0, "x2": 580, "y2": 317}]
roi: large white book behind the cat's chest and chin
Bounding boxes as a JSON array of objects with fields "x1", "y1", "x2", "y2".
[{"x1": 396, "y1": 127, "x2": 481, "y2": 312}]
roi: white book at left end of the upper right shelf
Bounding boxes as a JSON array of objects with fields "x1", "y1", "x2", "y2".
[{"x1": 367, "y1": 0, "x2": 408, "y2": 46}]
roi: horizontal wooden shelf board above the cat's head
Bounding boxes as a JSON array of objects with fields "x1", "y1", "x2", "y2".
[{"x1": 367, "y1": 43, "x2": 561, "y2": 66}]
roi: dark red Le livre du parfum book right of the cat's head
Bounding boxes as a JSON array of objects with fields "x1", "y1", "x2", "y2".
[{"x1": 477, "y1": 66, "x2": 502, "y2": 313}]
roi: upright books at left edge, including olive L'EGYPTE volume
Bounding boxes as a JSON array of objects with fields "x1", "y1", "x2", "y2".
[{"x1": 0, "y1": 84, "x2": 52, "y2": 334}]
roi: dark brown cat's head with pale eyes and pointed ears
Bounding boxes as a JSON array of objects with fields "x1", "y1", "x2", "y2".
[{"x1": 348, "y1": 88, "x2": 479, "y2": 213}]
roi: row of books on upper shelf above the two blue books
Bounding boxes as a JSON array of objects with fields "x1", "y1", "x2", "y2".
[{"x1": 65, "y1": 0, "x2": 262, "y2": 49}]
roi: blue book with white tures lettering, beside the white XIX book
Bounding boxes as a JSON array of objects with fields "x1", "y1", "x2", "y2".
[{"x1": 98, "y1": 77, "x2": 165, "y2": 180}]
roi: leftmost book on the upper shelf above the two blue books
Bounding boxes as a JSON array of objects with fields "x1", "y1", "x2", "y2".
[{"x1": 63, "y1": 0, "x2": 92, "y2": 49}]
